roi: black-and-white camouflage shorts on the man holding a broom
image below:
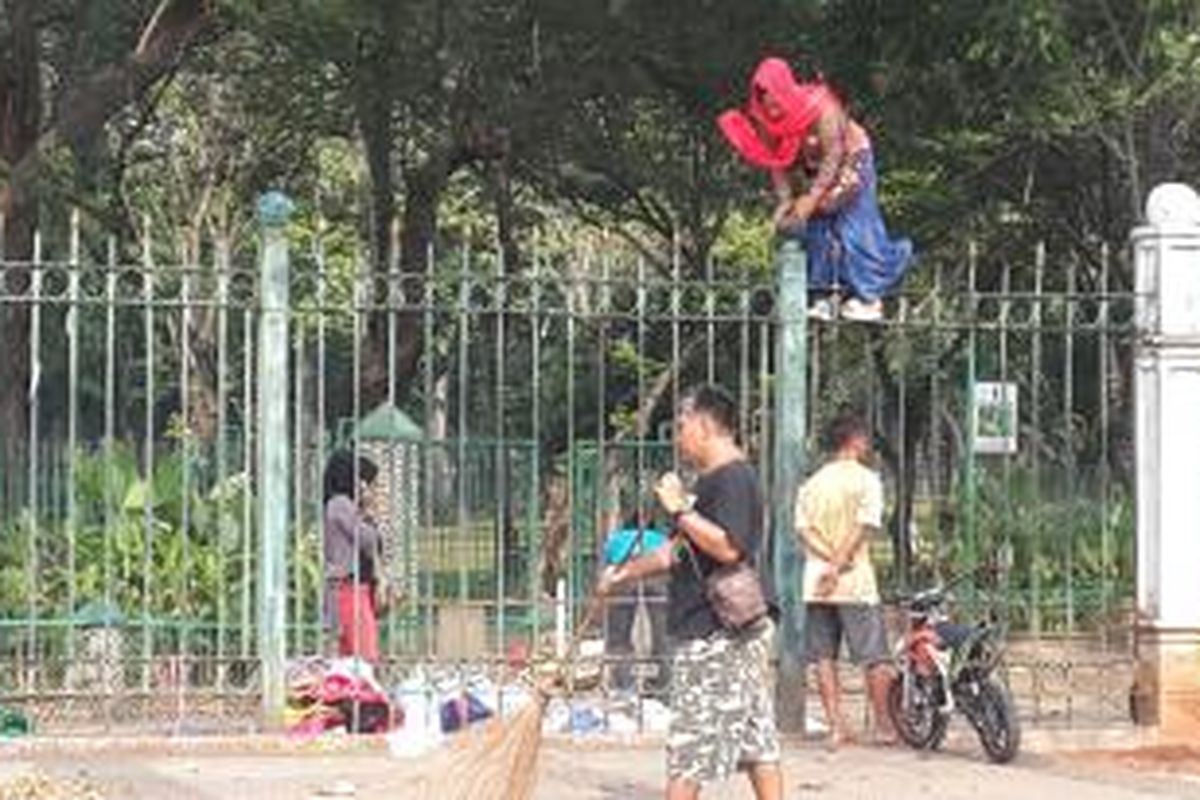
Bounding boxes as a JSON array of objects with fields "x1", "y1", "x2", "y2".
[{"x1": 667, "y1": 620, "x2": 779, "y2": 784}]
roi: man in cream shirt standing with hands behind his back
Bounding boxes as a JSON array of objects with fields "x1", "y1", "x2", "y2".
[{"x1": 796, "y1": 414, "x2": 894, "y2": 746}]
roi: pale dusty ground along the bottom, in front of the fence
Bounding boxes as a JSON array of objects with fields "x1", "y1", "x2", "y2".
[{"x1": 0, "y1": 735, "x2": 1200, "y2": 800}]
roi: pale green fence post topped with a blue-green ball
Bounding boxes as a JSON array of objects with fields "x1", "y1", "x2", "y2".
[{"x1": 257, "y1": 192, "x2": 293, "y2": 728}]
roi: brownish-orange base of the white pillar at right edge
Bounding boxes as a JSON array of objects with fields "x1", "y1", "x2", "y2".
[{"x1": 1133, "y1": 626, "x2": 1200, "y2": 741}]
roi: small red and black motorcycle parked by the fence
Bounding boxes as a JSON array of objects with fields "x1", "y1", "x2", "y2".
[{"x1": 888, "y1": 588, "x2": 1021, "y2": 764}]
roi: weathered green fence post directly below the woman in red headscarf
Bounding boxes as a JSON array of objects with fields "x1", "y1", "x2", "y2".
[{"x1": 770, "y1": 231, "x2": 809, "y2": 733}]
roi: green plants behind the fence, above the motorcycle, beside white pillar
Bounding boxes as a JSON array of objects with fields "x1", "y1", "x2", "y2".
[{"x1": 902, "y1": 463, "x2": 1135, "y2": 632}]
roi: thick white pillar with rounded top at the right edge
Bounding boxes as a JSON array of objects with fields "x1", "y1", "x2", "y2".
[{"x1": 1133, "y1": 184, "x2": 1200, "y2": 736}]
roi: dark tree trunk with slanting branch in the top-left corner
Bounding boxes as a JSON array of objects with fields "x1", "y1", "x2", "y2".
[{"x1": 0, "y1": 0, "x2": 215, "y2": 440}]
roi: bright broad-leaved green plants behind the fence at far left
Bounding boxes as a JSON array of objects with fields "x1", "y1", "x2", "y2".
[{"x1": 0, "y1": 445, "x2": 279, "y2": 622}]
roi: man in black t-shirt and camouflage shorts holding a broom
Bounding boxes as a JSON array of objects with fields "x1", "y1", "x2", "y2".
[{"x1": 600, "y1": 385, "x2": 784, "y2": 800}]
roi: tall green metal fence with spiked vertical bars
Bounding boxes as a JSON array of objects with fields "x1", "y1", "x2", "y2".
[{"x1": 0, "y1": 209, "x2": 1135, "y2": 728}]
